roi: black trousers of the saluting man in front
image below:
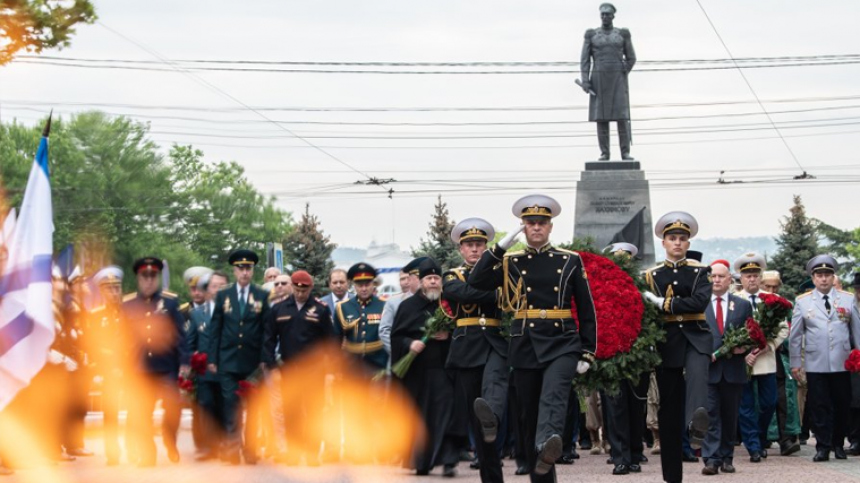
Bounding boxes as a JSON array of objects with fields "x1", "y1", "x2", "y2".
[{"x1": 513, "y1": 354, "x2": 579, "y2": 483}]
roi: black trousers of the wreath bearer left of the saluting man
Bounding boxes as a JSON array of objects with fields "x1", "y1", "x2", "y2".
[{"x1": 457, "y1": 351, "x2": 508, "y2": 483}]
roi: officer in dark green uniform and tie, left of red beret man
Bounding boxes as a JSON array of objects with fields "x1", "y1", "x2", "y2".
[{"x1": 211, "y1": 249, "x2": 269, "y2": 465}]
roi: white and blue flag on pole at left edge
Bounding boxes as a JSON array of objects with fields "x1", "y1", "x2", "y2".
[{"x1": 0, "y1": 119, "x2": 54, "y2": 410}]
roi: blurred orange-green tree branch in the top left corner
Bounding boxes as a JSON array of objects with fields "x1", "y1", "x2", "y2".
[{"x1": 0, "y1": 0, "x2": 96, "y2": 65}]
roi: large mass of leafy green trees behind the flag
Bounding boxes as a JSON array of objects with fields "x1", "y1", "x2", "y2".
[{"x1": 0, "y1": 112, "x2": 291, "y2": 293}]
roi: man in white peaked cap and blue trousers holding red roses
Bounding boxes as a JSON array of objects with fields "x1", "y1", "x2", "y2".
[{"x1": 734, "y1": 252, "x2": 788, "y2": 463}]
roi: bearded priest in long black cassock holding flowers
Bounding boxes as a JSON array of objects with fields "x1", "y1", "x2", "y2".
[{"x1": 391, "y1": 259, "x2": 458, "y2": 477}]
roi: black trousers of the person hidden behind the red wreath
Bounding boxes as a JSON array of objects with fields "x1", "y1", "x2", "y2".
[{"x1": 603, "y1": 374, "x2": 650, "y2": 466}]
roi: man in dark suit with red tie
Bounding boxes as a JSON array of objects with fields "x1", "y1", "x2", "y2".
[{"x1": 702, "y1": 260, "x2": 752, "y2": 475}]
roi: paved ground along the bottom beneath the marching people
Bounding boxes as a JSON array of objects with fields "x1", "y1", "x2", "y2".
[{"x1": 5, "y1": 431, "x2": 860, "y2": 483}]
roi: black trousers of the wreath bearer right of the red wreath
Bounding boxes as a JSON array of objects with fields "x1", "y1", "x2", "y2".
[{"x1": 656, "y1": 344, "x2": 711, "y2": 482}]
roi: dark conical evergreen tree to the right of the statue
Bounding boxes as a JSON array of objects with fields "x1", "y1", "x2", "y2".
[{"x1": 770, "y1": 195, "x2": 819, "y2": 297}]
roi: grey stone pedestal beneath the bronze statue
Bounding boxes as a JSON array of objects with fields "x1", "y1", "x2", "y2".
[{"x1": 573, "y1": 161, "x2": 654, "y2": 267}]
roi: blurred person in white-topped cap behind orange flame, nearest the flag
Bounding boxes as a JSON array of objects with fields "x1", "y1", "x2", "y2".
[{"x1": 83, "y1": 265, "x2": 128, "y2": 466}]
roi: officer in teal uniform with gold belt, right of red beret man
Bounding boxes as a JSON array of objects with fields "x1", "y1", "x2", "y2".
[{"x1": 336, "y1": 262, "x2": 388, "y2": 371}]
